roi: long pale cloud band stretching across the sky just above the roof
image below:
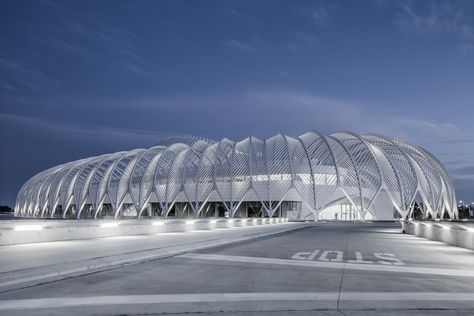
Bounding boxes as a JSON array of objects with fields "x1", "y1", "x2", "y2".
[{"x1": 5, "y1": 90, "x2": 474, "y2": 147}]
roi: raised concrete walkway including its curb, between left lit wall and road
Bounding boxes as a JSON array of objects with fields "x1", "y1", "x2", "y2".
[{"x1": 0, "y1": 223, "x2": 304, "y2": 292}]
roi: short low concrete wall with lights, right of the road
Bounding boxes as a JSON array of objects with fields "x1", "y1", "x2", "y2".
[{"x1": 402, "y1": 221, "x2": 474, "y2": 250}]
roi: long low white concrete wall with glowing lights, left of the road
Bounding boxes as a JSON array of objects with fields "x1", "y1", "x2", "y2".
[{"x1": 0, "y1": 218, "x2": 287, "y2": 246}]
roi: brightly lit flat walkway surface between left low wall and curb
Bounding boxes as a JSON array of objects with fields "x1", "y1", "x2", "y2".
[{"x1": 0, "y1": 223, "x2": 298, "y2": 273}]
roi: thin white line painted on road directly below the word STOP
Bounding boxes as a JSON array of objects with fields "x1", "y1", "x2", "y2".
[{"x1": 177, "y1": 253, "x2": 474, "y2": 278}]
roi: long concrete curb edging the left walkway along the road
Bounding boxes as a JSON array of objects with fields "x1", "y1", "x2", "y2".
[{"x1": 0, "y1": 223, "x2": 308, "y2": 293}]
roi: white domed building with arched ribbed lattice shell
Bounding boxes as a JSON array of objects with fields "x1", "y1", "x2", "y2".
[{"x1": 15, "y1": 131, "x2": 457, "y2": 220}]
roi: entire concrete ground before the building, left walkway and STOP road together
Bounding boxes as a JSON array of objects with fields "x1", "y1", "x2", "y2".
[{"x1": 0, "y1": 223, "x2": 474, "y2": 315}]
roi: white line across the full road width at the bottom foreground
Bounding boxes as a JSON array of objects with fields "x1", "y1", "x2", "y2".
[{"x1": 0, "y1": 292, "x2": 474, "y2": 310}]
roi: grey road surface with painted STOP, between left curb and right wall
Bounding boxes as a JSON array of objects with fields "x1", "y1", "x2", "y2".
[{"x1": 0, "y1": 223, "x2": 474, "y2": 315}]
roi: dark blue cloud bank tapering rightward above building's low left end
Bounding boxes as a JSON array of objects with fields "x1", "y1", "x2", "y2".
[{"x1": 0, "y1": 113, "x2": 170, "y2": 205}]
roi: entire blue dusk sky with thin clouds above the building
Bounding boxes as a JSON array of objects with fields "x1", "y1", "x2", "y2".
[{"x1": 0, "y1": 0, "x2": 474, "y2": 206}]
